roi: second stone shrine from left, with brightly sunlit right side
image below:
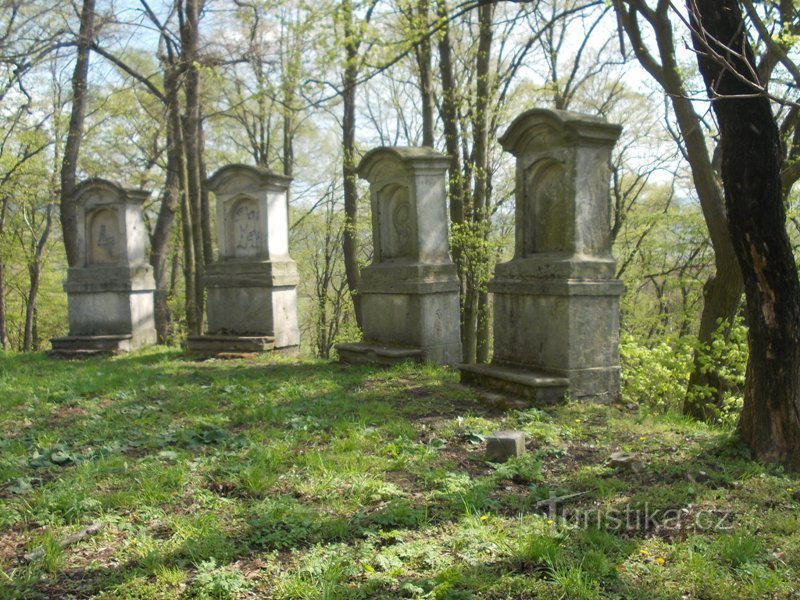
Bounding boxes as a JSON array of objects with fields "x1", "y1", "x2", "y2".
[{"x1": 187, "y1": 165, "x2": 300, "y2": 353}]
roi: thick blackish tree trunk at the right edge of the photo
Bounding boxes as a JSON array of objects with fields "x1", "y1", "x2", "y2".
[{"x1": 687, "y1": 0, "x2": 800, "y2": 471}]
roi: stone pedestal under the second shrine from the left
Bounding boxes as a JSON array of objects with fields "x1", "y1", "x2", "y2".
[{"x1": 202, "y1": 260, "x2": 300, "y2": 352}]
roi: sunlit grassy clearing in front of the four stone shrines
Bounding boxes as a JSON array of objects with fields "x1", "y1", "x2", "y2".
[{"x1": 0, "y1": 348, "x2": 800, "y2": 599}]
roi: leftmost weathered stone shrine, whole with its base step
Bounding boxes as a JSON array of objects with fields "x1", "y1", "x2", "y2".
[{"x1": 51, "y1": 179, "x2": 156, "y2": 356}]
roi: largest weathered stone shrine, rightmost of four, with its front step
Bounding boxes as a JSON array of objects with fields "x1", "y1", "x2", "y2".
[{"x1": 461, "y1": 109, "x2": 623, "y2": 402}]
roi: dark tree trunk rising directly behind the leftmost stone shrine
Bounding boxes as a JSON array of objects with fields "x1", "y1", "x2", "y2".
[{"x1": 61, "y1": 0, "x2": 94, "y2": 267}]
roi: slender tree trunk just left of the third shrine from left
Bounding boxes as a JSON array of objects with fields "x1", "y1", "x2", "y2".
[{"x1": 342, "y1": 0, "x2": 362, "y2": 327}]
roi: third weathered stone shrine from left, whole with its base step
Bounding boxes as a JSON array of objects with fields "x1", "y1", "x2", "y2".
[{"x1": 336, "y1": 147, "x2": 461, "y2": 364}]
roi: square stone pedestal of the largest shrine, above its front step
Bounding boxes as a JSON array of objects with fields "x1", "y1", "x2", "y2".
[{"x1": 489, "y1": 260, "x2": 624, "y2": 401}]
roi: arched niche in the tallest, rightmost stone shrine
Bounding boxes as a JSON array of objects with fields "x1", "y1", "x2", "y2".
[{"x1": 521, "y1": 159, "x2": 571, "y2": 256}]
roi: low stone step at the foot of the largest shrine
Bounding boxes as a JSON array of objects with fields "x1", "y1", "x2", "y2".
[{"x1": 459, "y1": 364, "x2": 570, "y2": 406}]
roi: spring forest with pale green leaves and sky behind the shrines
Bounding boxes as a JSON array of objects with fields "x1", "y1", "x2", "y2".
[{"x1": 0, "y1": 0, "x2": 800, "y2": 423}]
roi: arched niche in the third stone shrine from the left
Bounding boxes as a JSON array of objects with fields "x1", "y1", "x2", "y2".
[{"x1": 378, "y1": 183, "x2": 415, "y2": 261}]
